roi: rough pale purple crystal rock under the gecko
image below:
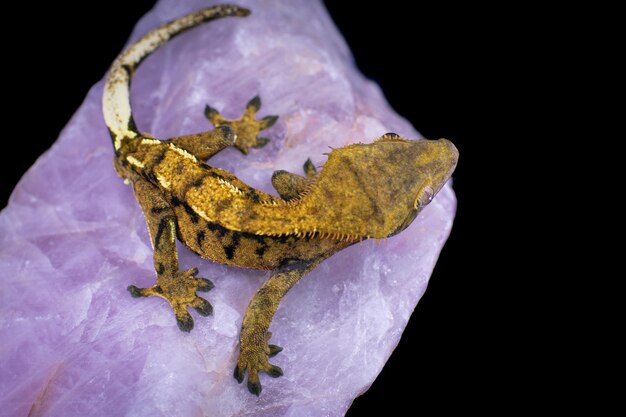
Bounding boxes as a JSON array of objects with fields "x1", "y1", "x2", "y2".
[{"x1": 0, "y1": 0, "x2": 456, "y2": 417}]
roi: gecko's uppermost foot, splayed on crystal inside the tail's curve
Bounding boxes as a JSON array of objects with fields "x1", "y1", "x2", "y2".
[{"x1": 204, "y1": 96, "x2": 278, "y2": 154}]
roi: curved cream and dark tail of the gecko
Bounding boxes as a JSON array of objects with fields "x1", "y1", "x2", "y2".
[{"x1": 102, "y1": 5, "x2": 250, "y2": 153}]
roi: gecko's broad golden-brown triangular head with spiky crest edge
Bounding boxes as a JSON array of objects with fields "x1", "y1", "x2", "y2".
[{"x1": 322, "y1": 133, "x2": 459, "y2": 238}]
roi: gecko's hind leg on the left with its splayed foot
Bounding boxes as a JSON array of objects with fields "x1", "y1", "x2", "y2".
[{"x1": 128, "y1": 180, "x2": 214, "y2": 332}]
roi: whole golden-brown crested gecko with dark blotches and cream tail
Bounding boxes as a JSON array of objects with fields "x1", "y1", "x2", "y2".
[{"x1": 102, "y1": 5, "x2": 458, "y2": 396}]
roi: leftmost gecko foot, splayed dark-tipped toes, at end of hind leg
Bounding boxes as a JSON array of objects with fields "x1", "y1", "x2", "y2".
[{"x1": 128, "y1": 268, "x2": 214, "y2": 332}]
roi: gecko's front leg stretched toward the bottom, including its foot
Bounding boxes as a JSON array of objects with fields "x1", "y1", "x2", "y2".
[{"x1": 234, "y1": 257, "x2": 325, "y2": 396}]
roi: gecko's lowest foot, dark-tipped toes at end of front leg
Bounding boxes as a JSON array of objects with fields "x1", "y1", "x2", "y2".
[{"x1": 233, "y1": 332, "x2": 283, "y2": 397}]
